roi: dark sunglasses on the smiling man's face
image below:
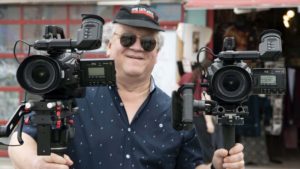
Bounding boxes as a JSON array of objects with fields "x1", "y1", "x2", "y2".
[{"x1": 114, "y1": 33, "x2": 156, "y2": 52}]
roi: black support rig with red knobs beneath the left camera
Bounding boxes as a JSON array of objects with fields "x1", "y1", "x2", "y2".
[{"x1": 0, "y1": 100, "x2": 78, "y2": 155}]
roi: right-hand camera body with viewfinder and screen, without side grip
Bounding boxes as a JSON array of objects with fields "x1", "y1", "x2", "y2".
[{"x1": 202, "y1": 30, "x2": 286, "y2": 119}]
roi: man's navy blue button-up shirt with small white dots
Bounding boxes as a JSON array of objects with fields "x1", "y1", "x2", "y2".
[{"x1": 25, "y1": 86, "x2": 203, "y2": 169}]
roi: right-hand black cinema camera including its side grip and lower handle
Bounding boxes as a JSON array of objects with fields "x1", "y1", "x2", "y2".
[{"x1": 172, "y1": 30, "x2": 286, "y2": 148}]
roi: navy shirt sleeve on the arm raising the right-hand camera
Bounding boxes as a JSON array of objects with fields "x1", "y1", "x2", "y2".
[{"x1": 176, "y1": 129, "x2": 203, "y2": 169}]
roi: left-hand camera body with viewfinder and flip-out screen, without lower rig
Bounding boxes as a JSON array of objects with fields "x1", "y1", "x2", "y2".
[{"x1": 17, "y1": 14, "x2": 115, "y2": 99}]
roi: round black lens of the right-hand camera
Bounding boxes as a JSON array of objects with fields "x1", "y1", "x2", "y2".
[{"x1": 212, "y1": 66, "x2": 252, "y2": 103}]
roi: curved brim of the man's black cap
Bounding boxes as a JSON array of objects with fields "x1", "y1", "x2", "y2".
[{"x1": 113, "y1": 19, "x2": 165, "y2": 31}]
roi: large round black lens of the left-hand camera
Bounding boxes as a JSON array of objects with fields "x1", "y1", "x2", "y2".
[{"x1": 17, "y1": 55, "x2": 61, "y2": 94}]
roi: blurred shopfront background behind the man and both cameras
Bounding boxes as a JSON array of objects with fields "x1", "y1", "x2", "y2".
[{"x1": 0, "y1": 0, "x2": 300, "y2": 169}]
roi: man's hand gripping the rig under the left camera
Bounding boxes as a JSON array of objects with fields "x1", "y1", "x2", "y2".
[{"x1": 33, "y1": 153, "x2": 73, "y2": 169}]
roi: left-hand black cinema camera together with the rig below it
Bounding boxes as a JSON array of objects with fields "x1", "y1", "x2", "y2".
[{"x1": 0, "y1": 14, "x2": 115, "y2": 155}]
